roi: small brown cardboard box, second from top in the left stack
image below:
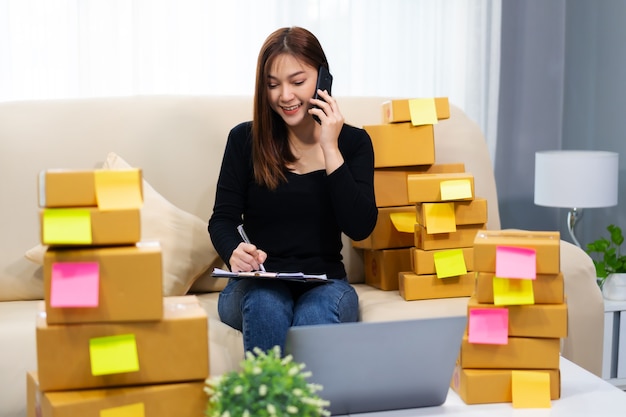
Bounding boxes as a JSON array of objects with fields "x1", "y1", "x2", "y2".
[{"x1": 39, "y1": 207, "x2": 141, "y2": 246}]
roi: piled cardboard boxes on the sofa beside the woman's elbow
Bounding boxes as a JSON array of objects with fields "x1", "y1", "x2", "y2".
[{"x1": 353, "y1": 98, "x2": 487, "y2": 300}]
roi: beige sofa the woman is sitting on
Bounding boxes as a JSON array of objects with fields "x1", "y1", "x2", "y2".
[{"x1": 0, "y1": 96, "x2": 603, "y2": 417}]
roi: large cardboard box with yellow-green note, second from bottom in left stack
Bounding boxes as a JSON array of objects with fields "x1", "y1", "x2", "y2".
[{"x1": 36, "y1": 296, "x2": 209, "y2": 392}]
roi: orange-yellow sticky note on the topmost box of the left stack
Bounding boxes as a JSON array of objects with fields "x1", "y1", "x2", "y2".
[{"x1": 95, "y1": 169, "x2": 143, "y2": 210}]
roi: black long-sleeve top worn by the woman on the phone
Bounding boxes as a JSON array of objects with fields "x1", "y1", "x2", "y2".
[{"x1": 208, "y1": 122, "x2": 378, "y2": 278}]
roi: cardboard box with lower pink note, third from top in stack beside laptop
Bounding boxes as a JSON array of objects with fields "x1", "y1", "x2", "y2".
[{"x1": 467, "y1": 297, "x2": 567, "y2": 338}]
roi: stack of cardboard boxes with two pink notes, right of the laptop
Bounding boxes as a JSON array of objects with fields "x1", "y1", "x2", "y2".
[{"x1": 451, "y1": 230, "x2": 567, "y2": 408}]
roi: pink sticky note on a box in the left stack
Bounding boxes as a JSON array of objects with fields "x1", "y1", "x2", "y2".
[{"x1": 50, "y1": 262, "x2": 100, "y2": 307}]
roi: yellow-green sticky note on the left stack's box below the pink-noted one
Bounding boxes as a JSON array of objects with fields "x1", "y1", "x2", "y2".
[{"x1": 89, "y1": 334, "x2": 139, "y2": 376}]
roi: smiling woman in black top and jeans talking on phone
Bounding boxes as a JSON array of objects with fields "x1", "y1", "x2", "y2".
[{"x1": 209, "y1": 27, "x2": 378, "y2": 351}]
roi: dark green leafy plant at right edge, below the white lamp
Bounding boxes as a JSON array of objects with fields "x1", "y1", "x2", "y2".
[{"x1": 587, "y1": 224, "x2": 626, "y2": 286}]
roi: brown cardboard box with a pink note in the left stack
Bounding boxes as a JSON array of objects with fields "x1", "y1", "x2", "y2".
[{"x1": 43, "y1": 242, "x2": 163, "y2": 324}]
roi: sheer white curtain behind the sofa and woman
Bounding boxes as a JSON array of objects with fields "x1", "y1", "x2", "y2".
[{"x1": 0, "y1": 0, "x2": 501, "y2": 160}]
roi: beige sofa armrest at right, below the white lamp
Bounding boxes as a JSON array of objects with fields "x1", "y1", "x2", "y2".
[{"x1": 561, "y1": 237, "x2": 604, "y2": 376}]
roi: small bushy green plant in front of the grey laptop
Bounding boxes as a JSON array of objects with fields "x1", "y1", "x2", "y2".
[{"x1": 205, "y1": 346, "x2": 330, "y2": 417}]
